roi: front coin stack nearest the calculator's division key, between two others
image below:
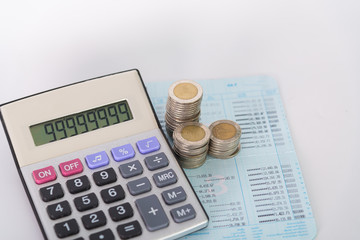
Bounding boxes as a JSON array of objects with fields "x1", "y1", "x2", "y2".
[{"x1": 173, "y1": 122, "x2": 211, "y2": 168}]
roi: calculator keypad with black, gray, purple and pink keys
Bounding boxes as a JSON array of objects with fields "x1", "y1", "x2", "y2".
[{"x1": 32, "y1": 133, "x2": 207, "y2": 240}]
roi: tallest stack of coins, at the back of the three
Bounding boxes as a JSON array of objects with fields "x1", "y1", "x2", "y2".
[{"x1": 165, "y1": 80, "x2": 203, "y2": 136}]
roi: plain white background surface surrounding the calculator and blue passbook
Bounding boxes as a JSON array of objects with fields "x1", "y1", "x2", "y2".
[{"x1": 0, "y1": 0, "x2": 360, "y2": 240}]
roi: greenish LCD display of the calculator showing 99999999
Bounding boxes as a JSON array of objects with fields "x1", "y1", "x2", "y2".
[{"x1": 30, "y1": 100, "x2": 133, "y2": 146}]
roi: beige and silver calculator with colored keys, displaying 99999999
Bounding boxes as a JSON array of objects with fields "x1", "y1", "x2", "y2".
[{"x1": 0, "y1": 70, "x2": 209, "y2": 240}]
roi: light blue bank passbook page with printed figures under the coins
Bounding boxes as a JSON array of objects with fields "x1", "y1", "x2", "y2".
[{"x1": 146, "y1": 76, "x2": 316, "y2": 240}]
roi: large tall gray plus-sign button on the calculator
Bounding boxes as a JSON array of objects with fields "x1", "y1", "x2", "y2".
[{"x1": 135, "y1": 195, "x2": 169, "y2": 232}]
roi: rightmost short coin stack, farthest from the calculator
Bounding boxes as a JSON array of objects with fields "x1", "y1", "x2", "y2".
[{"x1": 209, "y1": 120, "x2": 241, "y2": 159}]
